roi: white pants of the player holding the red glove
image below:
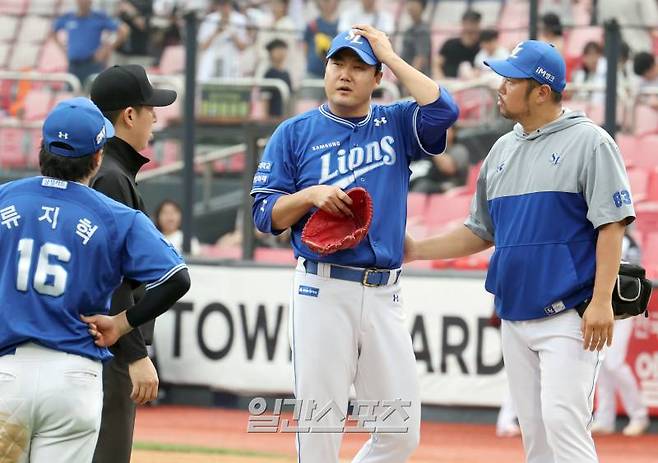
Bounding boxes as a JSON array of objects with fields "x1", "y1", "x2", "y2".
[{"x1": 290, "y1": 264, "x2": 420, "y2": 463}]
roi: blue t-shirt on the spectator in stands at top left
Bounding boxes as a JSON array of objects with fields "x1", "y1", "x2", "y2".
[{"x1": 54, "y1": 11, "x2": 119, "y2": 61}]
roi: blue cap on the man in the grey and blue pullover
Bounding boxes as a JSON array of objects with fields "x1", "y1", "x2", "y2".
[{"x1": 484, "y1": 40, "x2": 567, "y2": 93}]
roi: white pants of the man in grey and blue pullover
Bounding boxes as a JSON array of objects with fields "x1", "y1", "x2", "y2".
[{"x1": 502, "y1": 310, "x2": 603, "y2": 463}]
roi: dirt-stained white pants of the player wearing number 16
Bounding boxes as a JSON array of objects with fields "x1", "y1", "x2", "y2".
[{"x1": 0, "y1": 343, "x2": 103, "y2": 463}]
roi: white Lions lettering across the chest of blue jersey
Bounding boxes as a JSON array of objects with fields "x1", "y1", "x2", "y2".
[{"x1": 320, "y1": 135, "x2": 397, "y2": 188}]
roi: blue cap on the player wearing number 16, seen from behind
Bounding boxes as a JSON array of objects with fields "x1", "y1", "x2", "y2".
[{"x1": 42, "y1": 97, "x2": 114, "y2": 158}]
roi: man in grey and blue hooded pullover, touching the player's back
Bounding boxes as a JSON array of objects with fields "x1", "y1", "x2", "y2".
[{"x1": 405, "y1": 40, "x2": 635, "y2": 463}]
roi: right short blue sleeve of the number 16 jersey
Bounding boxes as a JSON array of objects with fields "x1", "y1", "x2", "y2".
[{"x1": 121, "y1": 212, "x2": 186, "y2": 284}]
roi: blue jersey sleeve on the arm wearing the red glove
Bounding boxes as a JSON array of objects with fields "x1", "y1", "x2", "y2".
[{"x1": 251, "y1": 123, "x2": 297, "y2": 234}]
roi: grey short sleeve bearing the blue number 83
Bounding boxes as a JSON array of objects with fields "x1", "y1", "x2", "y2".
[{"x1": 581, "y1": 138, "x2": 635, "y2": 228}]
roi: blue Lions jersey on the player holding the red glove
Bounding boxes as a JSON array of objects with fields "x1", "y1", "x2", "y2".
[{"x1": 251, "y1": 94, "x2": 458, "y2": 269}]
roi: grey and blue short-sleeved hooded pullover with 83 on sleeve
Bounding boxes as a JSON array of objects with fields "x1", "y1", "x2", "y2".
[{"x1": 465, "y1": 110, "x2": 635, "y2": 320}]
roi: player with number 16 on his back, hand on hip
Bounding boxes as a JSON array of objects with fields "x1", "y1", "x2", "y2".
[{"x1": 0, "y1": 98, "x2": 190, "y2": 463}]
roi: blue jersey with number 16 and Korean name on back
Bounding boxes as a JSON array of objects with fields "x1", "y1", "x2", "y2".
[{"x1": 0, "y1": 177, "x2": 185, "y2": 360}]
